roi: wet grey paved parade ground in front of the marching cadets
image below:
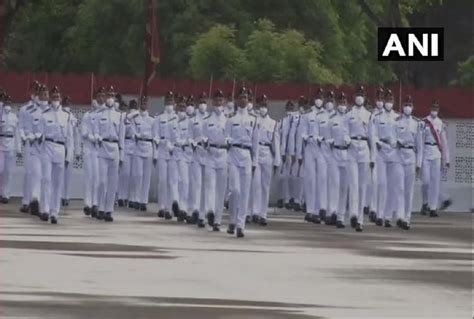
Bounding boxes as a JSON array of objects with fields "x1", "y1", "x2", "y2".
[{"x1": 0, "y1": 202, "x2": 473, "y2": 319}]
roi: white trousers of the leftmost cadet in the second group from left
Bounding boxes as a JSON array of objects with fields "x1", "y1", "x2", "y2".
[{"x1": 83, "y1": 152, "x2": 99, "y2": 207}]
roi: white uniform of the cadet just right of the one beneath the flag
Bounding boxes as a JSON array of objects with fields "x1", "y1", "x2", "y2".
[{"x1": 153, "y1": 111, "x2": 179, "y2": 212}]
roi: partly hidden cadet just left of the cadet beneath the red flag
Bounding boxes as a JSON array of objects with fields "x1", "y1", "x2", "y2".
[{"x1": 117, "y1": 100, "x2": 140, "y2": 209}]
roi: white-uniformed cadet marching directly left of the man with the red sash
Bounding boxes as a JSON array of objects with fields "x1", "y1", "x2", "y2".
[{"x1": 394, "y1": 96, "x2": 423, "y2": 230}]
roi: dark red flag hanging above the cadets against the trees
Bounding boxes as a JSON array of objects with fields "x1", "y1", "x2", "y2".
[{"x1": 141, "y1": 0, "x2": 160, "y2": 96}]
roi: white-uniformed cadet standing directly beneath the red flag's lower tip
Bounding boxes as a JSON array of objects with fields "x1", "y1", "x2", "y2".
[{"x1": 131, "y1": 96, "x2": 155, "y2": 211}]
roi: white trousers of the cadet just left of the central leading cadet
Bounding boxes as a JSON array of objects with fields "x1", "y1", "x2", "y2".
[{"x1": 204, "y1": 165, "x2": 227, "y2": 225}]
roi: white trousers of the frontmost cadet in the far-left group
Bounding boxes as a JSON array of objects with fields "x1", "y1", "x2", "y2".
[{"x1": 40, "y1": 156, "x2": 64, "y2": 217}]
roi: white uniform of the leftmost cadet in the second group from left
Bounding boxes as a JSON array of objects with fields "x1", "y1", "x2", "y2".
[{"x1": 81, "y1": 106, "x2": 104, "y2": 208}]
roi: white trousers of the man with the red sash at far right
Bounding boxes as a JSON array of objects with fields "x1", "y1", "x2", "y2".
[{"x1": 422, "y1": 158, "x2": 441, "y2": 210}]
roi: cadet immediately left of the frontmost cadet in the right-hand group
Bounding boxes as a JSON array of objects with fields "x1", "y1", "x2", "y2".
[{"x1": 326, "y1": 92, "x2": 351, "y2": 228}]
